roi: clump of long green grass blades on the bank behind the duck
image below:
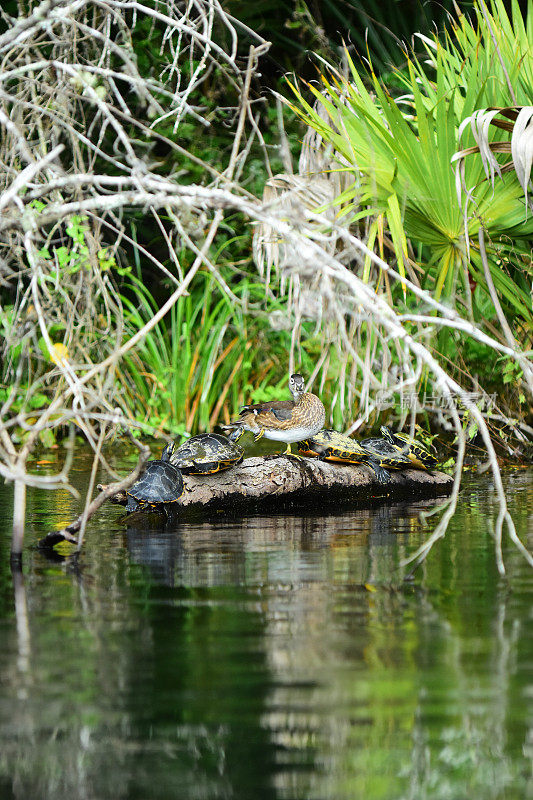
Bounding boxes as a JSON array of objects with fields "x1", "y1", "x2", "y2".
[{"x1": 119, "y1": 273, "x2": 296, "y2": 434}]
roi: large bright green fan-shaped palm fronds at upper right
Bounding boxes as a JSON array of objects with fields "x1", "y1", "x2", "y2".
[{"x1": 284, "y1": 2, "x2": 533, "y2": 323}]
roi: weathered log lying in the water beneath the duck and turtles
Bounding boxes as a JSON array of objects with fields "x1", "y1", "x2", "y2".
[{"x1": 164, "y1": 456, "x2": 453, "y2": 511}]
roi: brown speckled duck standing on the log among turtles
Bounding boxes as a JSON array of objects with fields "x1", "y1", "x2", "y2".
[{"x1": 223, "y1": 374, "x2": 326, "y2": 458}]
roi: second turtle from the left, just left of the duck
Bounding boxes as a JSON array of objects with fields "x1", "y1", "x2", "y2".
[{"x1": 161, "y1": 433, "x2": 244, "y2": 475}]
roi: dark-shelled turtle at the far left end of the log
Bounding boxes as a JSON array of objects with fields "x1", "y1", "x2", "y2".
[{"x1": 126, "y1": 460, "x2": 183, "y2": 514}]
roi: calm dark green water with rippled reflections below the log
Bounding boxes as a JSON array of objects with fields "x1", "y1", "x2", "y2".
[{"x1": 0, "y1": 456, "x2": 533, "y2": 800}]
